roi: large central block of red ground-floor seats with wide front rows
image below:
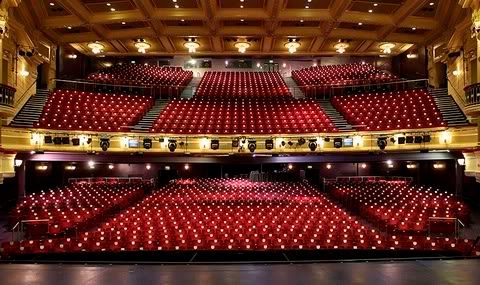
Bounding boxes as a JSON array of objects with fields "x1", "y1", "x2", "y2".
[{"x1": 2, "y1": 179, "x2": 472, "y2": 256}]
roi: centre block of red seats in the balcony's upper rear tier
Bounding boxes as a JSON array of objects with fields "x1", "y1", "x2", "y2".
[{"x1": 196, "y1": 71, "x2": 291, "y2": 97}]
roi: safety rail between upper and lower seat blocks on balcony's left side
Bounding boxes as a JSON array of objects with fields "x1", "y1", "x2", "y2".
[{"x1": 51, "y1": 78, "x2": 196, "y2": 98}]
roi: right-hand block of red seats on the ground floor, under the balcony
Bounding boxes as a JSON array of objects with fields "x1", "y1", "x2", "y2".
[{"x1": 327, "y1": 181, "x2": 469, "y2": 234}]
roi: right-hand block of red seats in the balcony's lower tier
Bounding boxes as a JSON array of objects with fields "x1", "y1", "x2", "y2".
[{"x1": 331, "y1": 89, "x2": 446, "y2": 131}]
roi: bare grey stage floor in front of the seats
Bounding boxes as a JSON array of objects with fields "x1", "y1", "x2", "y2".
[{"x1": 0, "y1": 259, "x2": 480, "y2": 285}]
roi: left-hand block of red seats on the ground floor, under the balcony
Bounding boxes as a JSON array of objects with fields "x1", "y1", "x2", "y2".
[{"x1": 10, "y1": 182, "x2": 144, "y2": 236}]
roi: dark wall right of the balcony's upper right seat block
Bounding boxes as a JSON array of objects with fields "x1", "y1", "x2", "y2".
[{"x1": 392, "y1": 47, "x2": 428, "y2": 79}]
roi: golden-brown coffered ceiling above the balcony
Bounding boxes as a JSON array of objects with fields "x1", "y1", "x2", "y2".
[{"x1": 19, "y1": 0, "x2": 465, "y2": 56}]
